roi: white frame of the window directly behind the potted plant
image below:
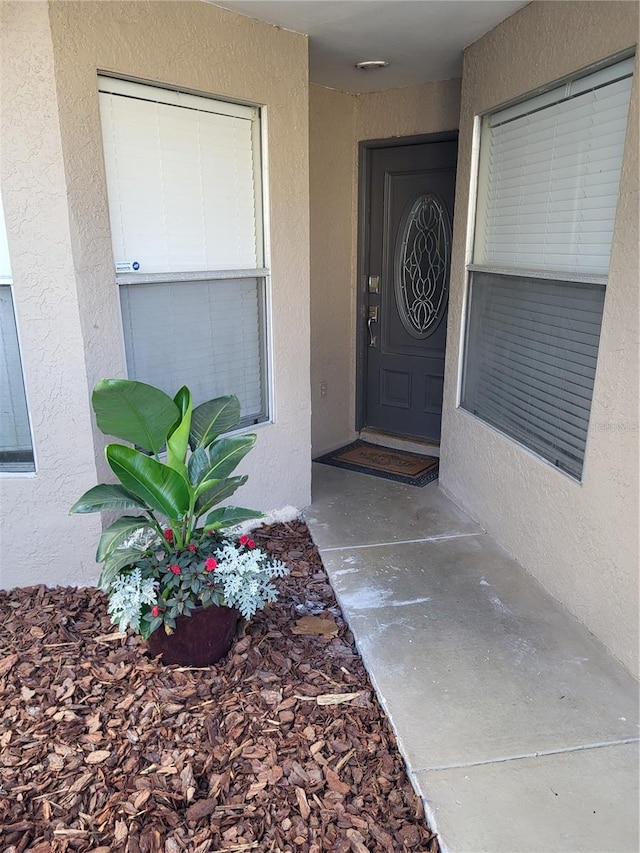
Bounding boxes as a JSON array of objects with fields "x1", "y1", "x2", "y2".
[{"x1": 98, "y1": 72, "x2": 274, "y2": 429}]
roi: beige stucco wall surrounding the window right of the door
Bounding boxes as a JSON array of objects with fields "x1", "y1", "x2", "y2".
[{"x1": 440, "y1": 2, "x2": 638, "y2": 671}]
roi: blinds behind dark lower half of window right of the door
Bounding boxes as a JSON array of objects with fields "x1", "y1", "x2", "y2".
[{"x1": 462, "y1": 272, "x2": 605, "y2": 478}]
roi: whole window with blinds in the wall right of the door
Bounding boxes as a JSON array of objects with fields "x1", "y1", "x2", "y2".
[{"x1": 461, "y1": 59, "x2": 633, "y2": 479}]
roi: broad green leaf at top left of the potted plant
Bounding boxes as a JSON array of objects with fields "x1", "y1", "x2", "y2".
[{"x1": 91, "y1": 379, "x2": 180, "y2": 456}]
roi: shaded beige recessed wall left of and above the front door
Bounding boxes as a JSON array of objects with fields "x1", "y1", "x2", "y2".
[{"x1": 310, "y1": 80, "x2": 460, "y2": 456}]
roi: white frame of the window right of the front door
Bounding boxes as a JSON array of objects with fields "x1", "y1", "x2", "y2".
[{"x1": 456, "y1": 51, "x2": 635, "y2": 484}]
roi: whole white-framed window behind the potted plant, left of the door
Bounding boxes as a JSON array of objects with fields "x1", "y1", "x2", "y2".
[{"x1": 99, "y1": 77, "x2": 268, "y2": 424}]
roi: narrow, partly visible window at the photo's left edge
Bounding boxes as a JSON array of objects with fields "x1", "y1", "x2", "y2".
[{"x1": 0, "y1": 194, "x2": 35, "y2": 473}]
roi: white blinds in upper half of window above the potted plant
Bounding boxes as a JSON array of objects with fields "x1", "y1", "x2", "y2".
[{"x1": 99, "y1": 77, "x2": 264, "y2": 274}]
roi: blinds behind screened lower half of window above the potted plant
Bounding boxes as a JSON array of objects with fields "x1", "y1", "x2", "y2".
[{"x1": 120, "y1": 278, "x2": 265, "y2": 423}]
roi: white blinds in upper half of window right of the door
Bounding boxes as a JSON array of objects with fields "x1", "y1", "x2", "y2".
[{"x1": 473, "y1": 59, "x2": 633, "y2": 275}]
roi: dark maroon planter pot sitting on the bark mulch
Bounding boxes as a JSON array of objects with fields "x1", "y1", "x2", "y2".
[{"x1": 147, "y1": 606, "x2": 240, "y2": 666}]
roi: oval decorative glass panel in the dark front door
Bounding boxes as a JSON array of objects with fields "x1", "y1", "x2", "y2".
[{"x1": 394, "y1": 193, "x2": 451, "y2": 338}]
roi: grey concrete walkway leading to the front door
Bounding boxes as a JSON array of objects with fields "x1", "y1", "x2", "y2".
[{"x1": 305, "y1": 465, "x2": 640, "y2": 853}]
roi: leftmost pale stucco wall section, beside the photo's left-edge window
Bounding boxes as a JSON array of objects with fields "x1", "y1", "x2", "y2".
[{"x1": 0, "y1": 2, "x2": 100, "y2": 587}]
